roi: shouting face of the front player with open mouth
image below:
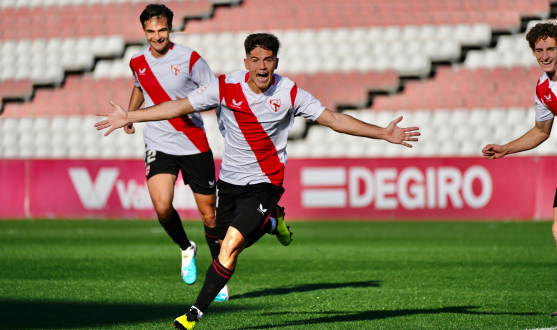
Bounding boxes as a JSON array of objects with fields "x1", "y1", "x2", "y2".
[{"x1": 244, "y1": 46, "x2": 278, "y2": 94}]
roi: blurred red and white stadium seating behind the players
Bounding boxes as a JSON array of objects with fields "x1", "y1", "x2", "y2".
[{"x1": 0, "y1": 0, "x2": 557, "y2": 159}]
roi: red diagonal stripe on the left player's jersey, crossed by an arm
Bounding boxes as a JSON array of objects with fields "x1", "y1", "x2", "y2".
[{"x1": 130, "y1": 55, "x2": 210, "y2": 152}]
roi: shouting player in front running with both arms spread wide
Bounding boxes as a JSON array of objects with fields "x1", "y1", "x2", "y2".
[{"x1": 95, "y1": 33, "x2": 420, "y2": 329}]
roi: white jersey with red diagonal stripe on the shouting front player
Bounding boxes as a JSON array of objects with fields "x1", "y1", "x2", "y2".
[{"x1": 188, "y1": 71, "x2": 325, "y2": 186}]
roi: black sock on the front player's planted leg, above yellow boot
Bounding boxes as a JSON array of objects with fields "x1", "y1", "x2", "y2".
[{"x1": 193, "y1": 258, "x2": 234, "y2": 313}]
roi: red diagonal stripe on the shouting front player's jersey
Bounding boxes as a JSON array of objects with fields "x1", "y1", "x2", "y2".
[{"x1": 219, "y1": 75, "x2": 284, "y2": 186}]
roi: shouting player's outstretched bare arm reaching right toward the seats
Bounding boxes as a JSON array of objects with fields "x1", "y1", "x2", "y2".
[{"x1": 317, "y1": 109, "x2": 420, "y2": 148}]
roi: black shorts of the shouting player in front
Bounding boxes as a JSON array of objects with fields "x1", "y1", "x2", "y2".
[{"x1": 216, "y1": 180, "x2": 284, "y2": 240}]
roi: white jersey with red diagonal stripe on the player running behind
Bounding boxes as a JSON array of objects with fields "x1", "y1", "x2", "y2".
[{"x1": 130, "y1": 43, "x2": 216, "y2": 156}]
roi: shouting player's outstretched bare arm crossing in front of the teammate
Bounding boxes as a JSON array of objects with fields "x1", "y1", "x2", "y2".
[{"x1": 95, "y1": 98, "x2": 195, "y2": 136}]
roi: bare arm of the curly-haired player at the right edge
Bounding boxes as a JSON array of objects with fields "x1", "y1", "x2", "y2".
[{"x1": 482, "y1": 119, "x2": 553, "y2": 160}]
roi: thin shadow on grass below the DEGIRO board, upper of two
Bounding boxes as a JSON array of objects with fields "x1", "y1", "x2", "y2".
[{"x1": 231, "y1": 281, "x2": 381, "y2": 300}]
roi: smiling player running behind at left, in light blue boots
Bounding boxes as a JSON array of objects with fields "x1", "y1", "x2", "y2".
[{"x1": 124, "y1": 4, "x2": 228, "y2": 301}]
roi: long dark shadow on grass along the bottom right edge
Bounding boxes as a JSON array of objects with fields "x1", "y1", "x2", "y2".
[{"x1": 234, "y1": 306, "x2": 541, "y2": 330}]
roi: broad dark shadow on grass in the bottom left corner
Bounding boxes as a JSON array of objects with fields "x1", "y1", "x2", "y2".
[{"x1": 0, "y1": 300, "x2": 244, "y2": 329}]
